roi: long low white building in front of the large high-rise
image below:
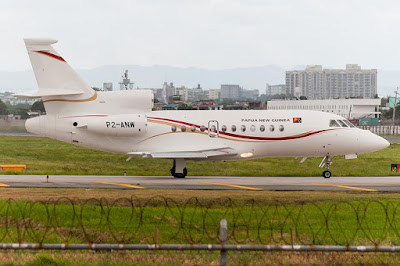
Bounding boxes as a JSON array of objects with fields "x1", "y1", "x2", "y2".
[{"x1": 267, "y1": 99, "x2": 381, "y2": 119}]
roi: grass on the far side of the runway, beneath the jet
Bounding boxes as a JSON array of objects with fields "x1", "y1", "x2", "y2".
[{"x1": 0, "y1": 136, "x2": 400, "y2": 176}]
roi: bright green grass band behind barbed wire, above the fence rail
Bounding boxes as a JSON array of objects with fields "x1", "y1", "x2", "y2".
[{"x1": 0, "y1": 197, "x2": 400, "y2": 246}]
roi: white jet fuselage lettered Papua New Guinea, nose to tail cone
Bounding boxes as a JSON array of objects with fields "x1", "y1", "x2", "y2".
[{"x1": 26, "y1": 105, "x2": 388, "y2": 160}]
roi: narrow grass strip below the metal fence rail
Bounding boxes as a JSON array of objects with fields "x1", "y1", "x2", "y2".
[{"x1": 0, "y1": 251, "x2": 400, "y2": 266}]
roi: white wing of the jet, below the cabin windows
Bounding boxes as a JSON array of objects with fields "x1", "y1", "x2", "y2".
[{"x1": 127, "y1": 147, "x2": 237, "y2": 161}]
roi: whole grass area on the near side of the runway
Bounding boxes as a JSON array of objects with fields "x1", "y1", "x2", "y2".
[{"x1": 0, "y1": 188, "x2": 400, "y2": 265}]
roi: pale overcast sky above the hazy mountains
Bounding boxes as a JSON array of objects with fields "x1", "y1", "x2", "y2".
[{"x1": 0, "y1": 0, "x2": 400, "y2": 71}]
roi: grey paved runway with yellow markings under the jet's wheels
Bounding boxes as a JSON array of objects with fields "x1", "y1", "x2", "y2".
[{"x1": 0, "y1": 175, "x2": 400, "y2": 192}]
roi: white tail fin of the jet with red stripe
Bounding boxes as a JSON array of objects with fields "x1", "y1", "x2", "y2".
[{"x1": 20, "y1": 39, "x2": 95, "y2": 100}]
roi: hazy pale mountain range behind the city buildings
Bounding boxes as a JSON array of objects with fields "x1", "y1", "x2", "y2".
[{"x1": 0, "y1": 65, "x2": 400, "y2": 96}]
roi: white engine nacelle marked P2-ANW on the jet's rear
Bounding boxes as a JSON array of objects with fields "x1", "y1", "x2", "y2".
[{"x1": 86, "y1": 114, "x2": 147, "y2": 137}]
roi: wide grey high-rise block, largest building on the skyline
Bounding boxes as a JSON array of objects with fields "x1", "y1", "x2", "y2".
[{"x1": 286, "y1": 64, "x2": 377, "y2": 100}]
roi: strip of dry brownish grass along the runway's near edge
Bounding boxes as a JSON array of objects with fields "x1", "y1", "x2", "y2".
[{"x1": 0, "y1": 188, "x2": 400, "y2": 206}]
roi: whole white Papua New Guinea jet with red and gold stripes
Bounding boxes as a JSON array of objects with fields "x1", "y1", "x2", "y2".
[{"x1": 17, "y1": 39, "x2": 389, "y2": 178}]
